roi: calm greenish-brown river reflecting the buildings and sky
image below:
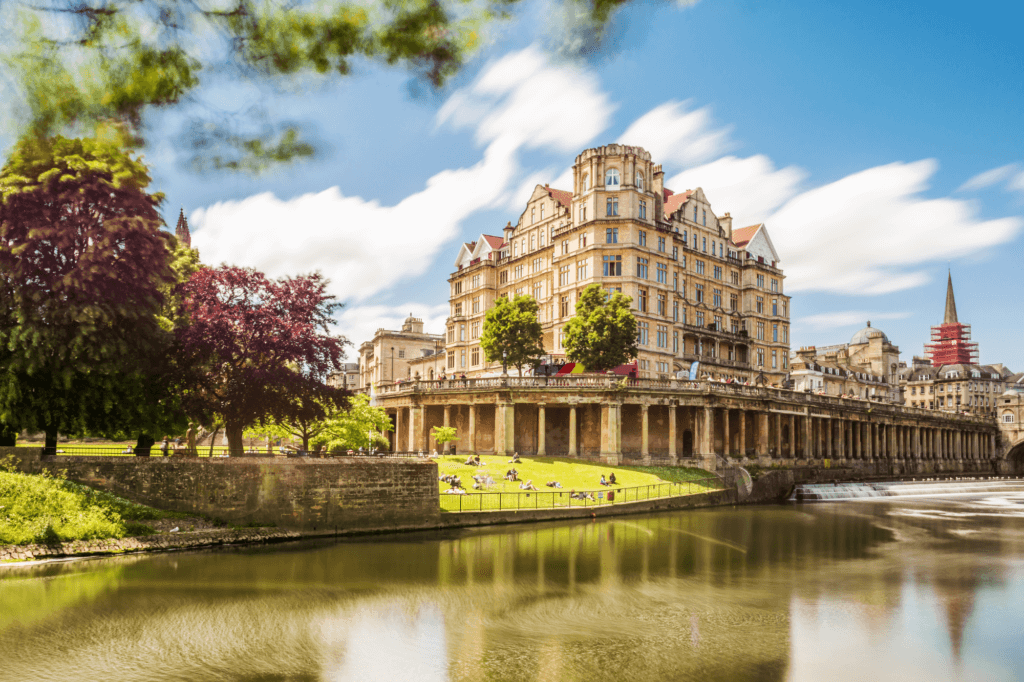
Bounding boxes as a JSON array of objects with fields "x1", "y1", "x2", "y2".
[{"x1": 0, "y1": 483, "x2": 1024, "y2": 682}]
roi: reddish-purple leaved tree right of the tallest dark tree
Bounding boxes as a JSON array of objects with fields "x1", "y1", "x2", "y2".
[{"x1": 176, "y1": 265, "x2": 348, "y2": 455}]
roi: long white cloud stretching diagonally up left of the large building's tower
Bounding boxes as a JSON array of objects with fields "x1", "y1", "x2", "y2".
[{"x1": 190, "y1": 47, "x2": 612, "y2": 301}]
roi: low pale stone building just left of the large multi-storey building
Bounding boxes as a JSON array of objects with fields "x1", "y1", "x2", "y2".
[{"x1": 359, "y1": 313, "x2": 444, "y2": 393}]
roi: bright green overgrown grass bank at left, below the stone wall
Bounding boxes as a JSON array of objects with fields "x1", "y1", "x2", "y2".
[{"x1": 0, "y1": 471, "x2": 183, "y2": 545}]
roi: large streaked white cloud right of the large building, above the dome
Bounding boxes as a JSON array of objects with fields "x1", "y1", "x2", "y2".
[{"x1": 767, "y1": 160, "x2": 1024, "y2": 294}]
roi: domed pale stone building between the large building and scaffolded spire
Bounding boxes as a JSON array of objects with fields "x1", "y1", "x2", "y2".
[{"x1": 790, "y1": 322, "x2": 900, "y2": 402}]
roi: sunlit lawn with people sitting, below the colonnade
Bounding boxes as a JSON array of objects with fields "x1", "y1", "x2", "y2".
[{"x1": 434, "y1": 455, "x2": 718, "y2": 511}]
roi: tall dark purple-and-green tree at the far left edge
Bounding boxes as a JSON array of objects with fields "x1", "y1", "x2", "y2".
[{"x1": 0, "y1": 137, "x2": 180, "y2": 447}]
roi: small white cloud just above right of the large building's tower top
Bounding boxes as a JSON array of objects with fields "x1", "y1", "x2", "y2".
[{"x1": 618, "y1": 101, "x2": 734, "y2": 168}]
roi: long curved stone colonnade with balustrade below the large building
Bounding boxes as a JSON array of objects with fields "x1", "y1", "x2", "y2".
[{"x1": 375, "y1": 375, "x2": 999, "y2": 475}]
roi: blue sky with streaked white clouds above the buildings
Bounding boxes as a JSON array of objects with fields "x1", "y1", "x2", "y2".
[{"x1": 0, "y1": 0, "x2": 1024, "y2": 372}]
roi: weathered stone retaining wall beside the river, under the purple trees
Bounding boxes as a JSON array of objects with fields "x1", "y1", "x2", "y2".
[{"x1": 0, "y1": 447, "x2": 440, "y2": 531}]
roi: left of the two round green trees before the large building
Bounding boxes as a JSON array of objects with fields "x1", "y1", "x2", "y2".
[{"x1": 480, "y1": 296, "x2": 544, "y2": 377}]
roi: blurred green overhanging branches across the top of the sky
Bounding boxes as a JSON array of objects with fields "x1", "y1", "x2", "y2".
[{"x1": 4, "y1": 0, "x2": 626, "y2": 171}]
